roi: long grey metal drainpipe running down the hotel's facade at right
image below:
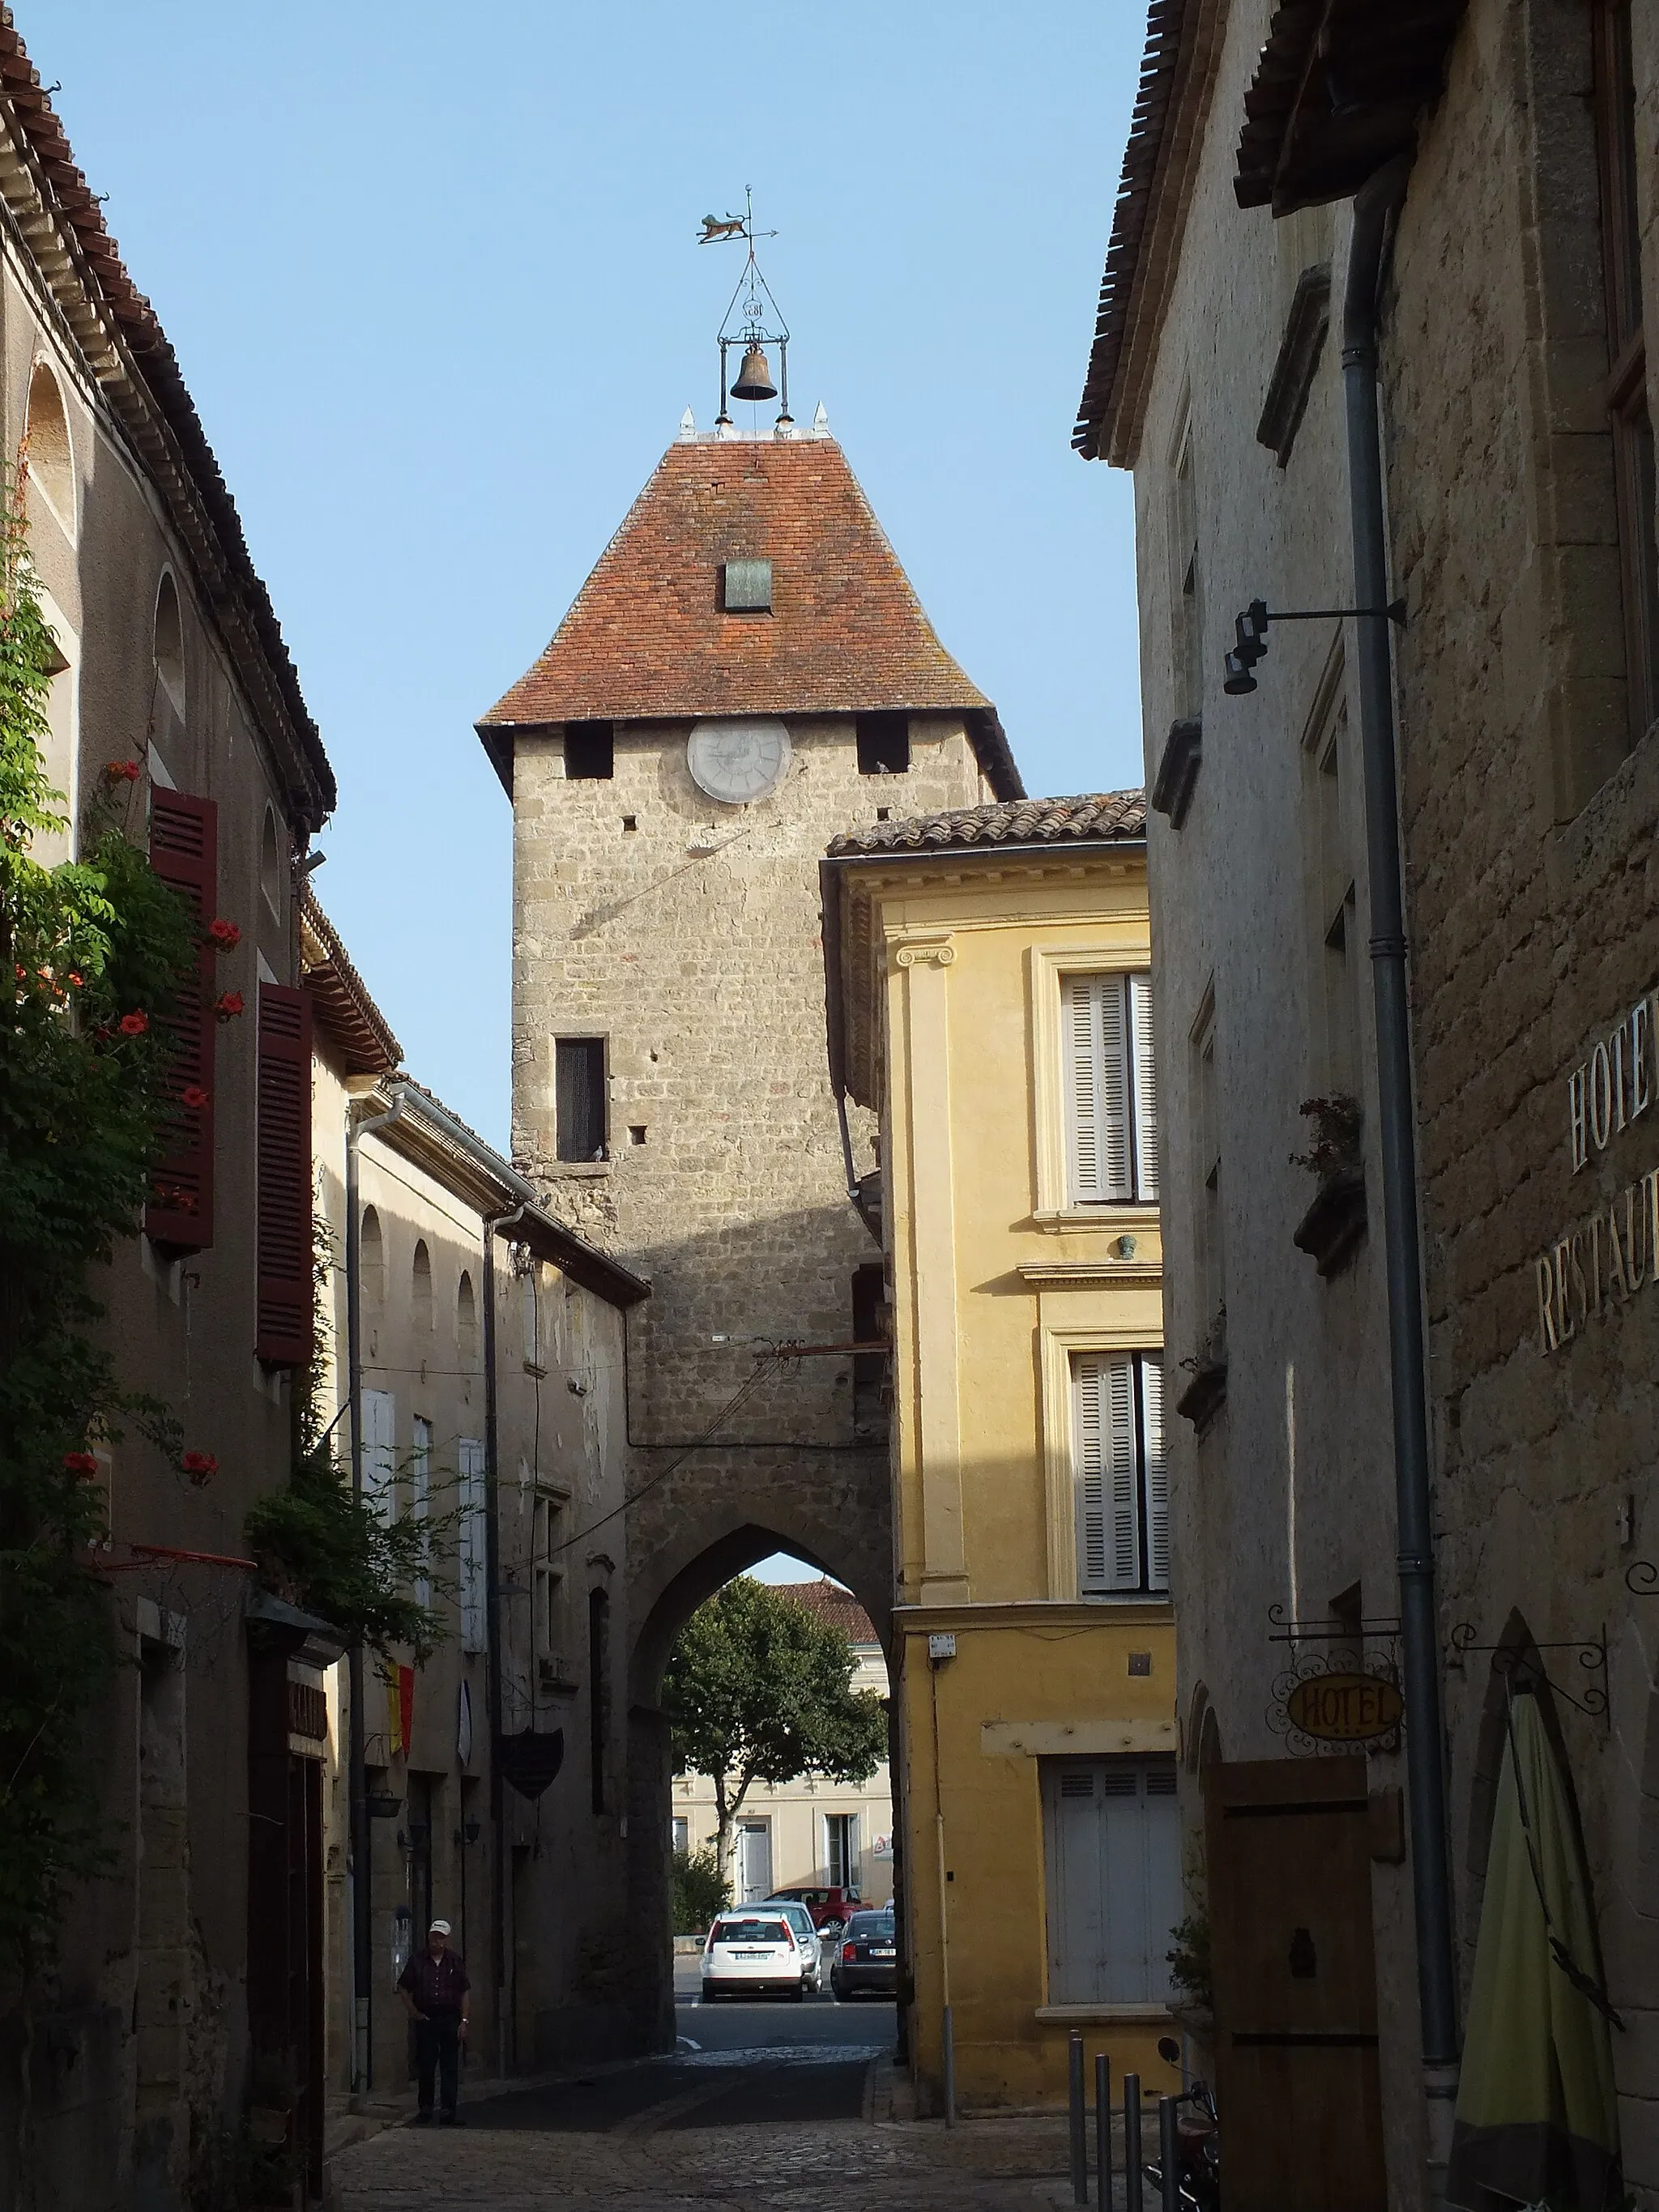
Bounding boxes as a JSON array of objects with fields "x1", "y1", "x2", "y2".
[{"x1": 1343, "y1": 155, "x2": 1458, "y2": 2105}]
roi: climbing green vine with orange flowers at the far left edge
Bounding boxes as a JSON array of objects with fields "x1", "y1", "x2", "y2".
[{"x1": 0, "y1": 487, "x2": 199, "y2": 1971}]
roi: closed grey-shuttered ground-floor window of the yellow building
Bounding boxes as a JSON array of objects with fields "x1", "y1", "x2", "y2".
[{"x1": 1042, "y1": 1758, "x2": 1183, "y2": 2004}]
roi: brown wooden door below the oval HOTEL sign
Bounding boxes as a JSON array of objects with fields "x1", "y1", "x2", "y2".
[{"x1": 1203, "y1": 1758, "x2": 1387, "y2": 2212}]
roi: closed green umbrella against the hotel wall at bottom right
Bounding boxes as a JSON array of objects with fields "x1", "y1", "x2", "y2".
[{"x1": 1447, "y1": 1690, "x2": 1626, "y2": 2212}]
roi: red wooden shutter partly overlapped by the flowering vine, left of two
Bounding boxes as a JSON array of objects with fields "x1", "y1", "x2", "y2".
[{"x1": 143, "y1": 783, "x2": 219, "y2": 1252}]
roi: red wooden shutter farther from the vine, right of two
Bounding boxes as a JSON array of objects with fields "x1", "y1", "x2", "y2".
[{"x1": 254, "y1": 982, "x2": 312, "y2": 1367}]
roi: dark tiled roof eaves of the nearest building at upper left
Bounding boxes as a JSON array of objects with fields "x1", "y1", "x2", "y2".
[{"x1": 0, "y1": 6, "x2": 336, "y2": 829}]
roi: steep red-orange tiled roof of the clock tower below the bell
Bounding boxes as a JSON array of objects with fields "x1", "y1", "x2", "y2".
[{"x1": 478, "y1": 436, "x2": 1020, "y2": 796}]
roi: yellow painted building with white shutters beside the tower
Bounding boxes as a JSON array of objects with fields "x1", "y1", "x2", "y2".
[{"x1": 823, "y1": 792, "x2": 1181, "y2": 2110}]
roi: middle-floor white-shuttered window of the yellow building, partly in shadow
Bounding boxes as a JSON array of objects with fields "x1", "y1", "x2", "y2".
[{"x1": 1071, "y1": 1352, "x2": 1171, "y2": 1597}]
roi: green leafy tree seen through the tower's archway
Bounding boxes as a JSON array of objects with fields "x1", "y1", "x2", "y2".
[{"x1": 661, "y1": 1575, "x2": 887, "y2": 1876}]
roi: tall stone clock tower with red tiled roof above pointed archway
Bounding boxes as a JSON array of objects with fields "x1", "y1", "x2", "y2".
[{"x1": 478, "y1": 409, "x2": 1020, "y2": 2035}]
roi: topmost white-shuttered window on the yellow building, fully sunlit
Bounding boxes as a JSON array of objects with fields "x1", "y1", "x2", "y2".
[{"x1": 1060, "y1": 971, "x2": 1157, "y2": 1205}]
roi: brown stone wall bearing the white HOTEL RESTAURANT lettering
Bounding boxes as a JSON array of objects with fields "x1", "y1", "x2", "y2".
[{"x1": 1384, "y1": 0, "x2": 1659, "y2": 2190}]
